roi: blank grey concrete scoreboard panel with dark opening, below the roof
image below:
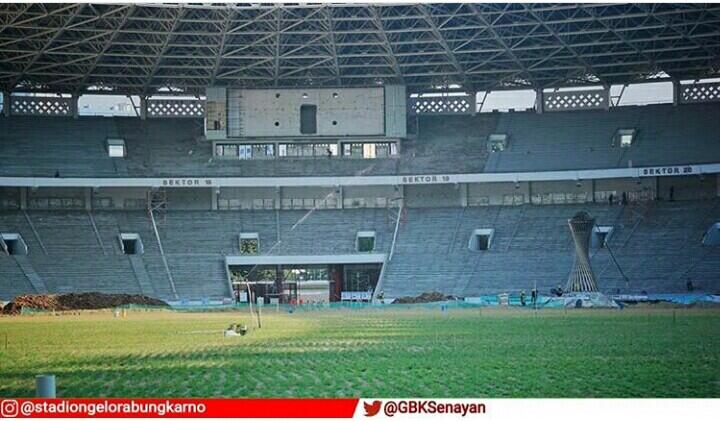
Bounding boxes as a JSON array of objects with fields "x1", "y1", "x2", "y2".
[{"x1": 228, "y1": 88, "x2": 385, "y2": 137}]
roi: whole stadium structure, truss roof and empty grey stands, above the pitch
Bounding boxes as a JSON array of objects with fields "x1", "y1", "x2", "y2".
[{"x1": 0, "y1": 5, "x2": 720, "y2": 302}]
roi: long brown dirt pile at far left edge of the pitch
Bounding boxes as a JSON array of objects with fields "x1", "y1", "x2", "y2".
[{"x1": 2, "y1": 292, "x2": 168, "y2": 314}]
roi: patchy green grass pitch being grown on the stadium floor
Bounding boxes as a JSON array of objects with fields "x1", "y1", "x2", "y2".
[{"x1": 0, "y1": 308, "x2": 720, "y2": 397}]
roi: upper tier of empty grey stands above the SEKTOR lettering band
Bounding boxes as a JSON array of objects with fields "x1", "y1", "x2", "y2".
[{"x1": 0, "y1": 103, "x2": 720, "y2": 177}]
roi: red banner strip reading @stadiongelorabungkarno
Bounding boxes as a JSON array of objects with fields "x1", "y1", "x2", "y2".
[{"x1": 0, "y1": 398, "x2": 358, "y2": 418}]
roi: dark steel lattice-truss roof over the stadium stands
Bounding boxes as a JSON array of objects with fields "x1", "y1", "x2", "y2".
[{"x1": 0, "y1": 3, "x2": 720, "y2": 94}]
